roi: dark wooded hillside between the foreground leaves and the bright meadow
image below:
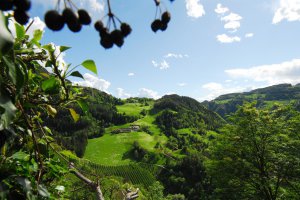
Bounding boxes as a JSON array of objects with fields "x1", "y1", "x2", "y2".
[{"x1": 44, "y1": 88, "x2": 136, "y2": 157}]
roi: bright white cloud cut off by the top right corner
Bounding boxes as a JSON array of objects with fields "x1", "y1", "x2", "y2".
[{"x1": 272, "y1": 0, "x2": 300, "y2": 24}]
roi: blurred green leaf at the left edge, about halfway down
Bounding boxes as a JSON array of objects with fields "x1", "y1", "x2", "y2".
[{"x1": 0, "y1": 91, "x2": 17, "y2": 131}]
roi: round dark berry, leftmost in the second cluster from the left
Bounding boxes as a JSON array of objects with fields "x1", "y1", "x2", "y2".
[{"x1": 45, "y1": 10, "x2": 65, "y2": 31}]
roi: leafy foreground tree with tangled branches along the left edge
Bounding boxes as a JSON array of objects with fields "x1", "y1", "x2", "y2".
[{"x1": 0, "y1": 12, "x2": 102, "y2": 199}]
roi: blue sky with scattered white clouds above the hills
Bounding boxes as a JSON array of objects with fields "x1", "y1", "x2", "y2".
[{"x1": 30, "y1": 0, "x2": 300, "y2": 101}]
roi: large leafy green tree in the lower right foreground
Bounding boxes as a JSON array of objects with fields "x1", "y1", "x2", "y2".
[{"x1": 208, "y1": 103, "x2": 300, "y2": 200}]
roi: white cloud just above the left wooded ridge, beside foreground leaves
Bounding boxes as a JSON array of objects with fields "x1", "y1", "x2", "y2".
[{"x1": 73, "y1": 73, "x2": 110, "y2": 93}]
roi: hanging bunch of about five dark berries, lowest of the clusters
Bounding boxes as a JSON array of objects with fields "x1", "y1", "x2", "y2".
[{"x1": 95, "y1": 12, "x2": 132, "y2": 49}]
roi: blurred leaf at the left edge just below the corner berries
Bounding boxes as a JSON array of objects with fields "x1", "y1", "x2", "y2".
[{"x1": 0, "y1": 12, "x2": 14, "y2": 59}]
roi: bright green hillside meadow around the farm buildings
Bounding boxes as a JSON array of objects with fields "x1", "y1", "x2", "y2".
[{"x1": 84, "y1": 103, "x2": 167, "y2": 165}]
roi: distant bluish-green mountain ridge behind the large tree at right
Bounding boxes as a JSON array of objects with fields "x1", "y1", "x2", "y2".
[{"x1": 202, "y1": 84, "x2": 300, "y2": 118}]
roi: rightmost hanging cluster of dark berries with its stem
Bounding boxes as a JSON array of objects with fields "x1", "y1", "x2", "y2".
[{"x1": 151, "y1": 0, "x2": 171, "y2": 33}]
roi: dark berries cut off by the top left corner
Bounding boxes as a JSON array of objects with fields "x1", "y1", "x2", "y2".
[{"x1": 0, "y1": 0, "x2": 31, "y2": 25}]
